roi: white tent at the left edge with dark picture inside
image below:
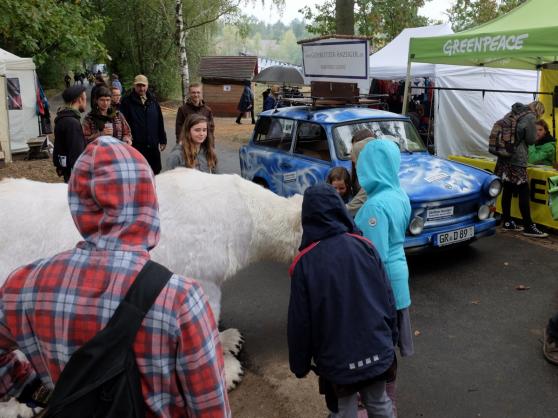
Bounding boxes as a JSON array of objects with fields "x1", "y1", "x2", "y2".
[{"x1": 0, "y1": 49, "x2": 40, "y2": 153}]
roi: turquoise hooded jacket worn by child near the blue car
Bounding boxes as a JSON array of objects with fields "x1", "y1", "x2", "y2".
[{"x1": 355, "y1": 139, "x2": 411, "y2": 310}]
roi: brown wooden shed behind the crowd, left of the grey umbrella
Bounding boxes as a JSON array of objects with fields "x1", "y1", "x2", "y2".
[{"x1": 199, "y1": 56, "x2": 258, "y2": 116}]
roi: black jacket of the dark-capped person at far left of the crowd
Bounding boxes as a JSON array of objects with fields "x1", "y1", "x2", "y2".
[{"x1": 52, "y1": 107, "x2": 86, "y2": 183}]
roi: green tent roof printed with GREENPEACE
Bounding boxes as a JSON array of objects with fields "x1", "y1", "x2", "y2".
[{"x1": 409, "y1": 0, "x2": 558, "y2": 69}]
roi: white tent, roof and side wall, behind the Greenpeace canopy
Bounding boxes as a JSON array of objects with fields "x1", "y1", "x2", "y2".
[{"x1": 369, "y1": 24, "x2": 537, "y2": 157}]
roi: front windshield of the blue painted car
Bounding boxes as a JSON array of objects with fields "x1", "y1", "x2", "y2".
[{"x1": 333, "y1": 120, "x2": 426, "y2": 160}]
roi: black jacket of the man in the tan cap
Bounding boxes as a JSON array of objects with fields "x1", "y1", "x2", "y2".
[{"x1": 120, "y1": 91, "x2": 167, "y2": 149}]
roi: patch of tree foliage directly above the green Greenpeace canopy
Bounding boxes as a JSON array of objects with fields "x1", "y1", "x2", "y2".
[{"x1": 447, "y1": 0, "x2": 526, "y2": 32}]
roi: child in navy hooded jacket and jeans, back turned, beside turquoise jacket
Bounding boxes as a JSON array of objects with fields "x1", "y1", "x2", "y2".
[{"x1": 287, "y1": 184, "x2": 398, "y2": 418}]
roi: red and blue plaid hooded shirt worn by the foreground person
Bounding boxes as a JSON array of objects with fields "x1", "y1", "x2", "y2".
[{"x1": 0, "y1": 137, "x2": 231, "y2": 418}]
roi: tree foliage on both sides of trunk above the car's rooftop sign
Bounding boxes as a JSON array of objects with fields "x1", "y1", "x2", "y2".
[{"x1": 300, "y1": 0, "x2": 428, "y2": 47}]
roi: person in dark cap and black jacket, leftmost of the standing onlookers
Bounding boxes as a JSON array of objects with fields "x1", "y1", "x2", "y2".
[{"x1": 52, "y1": 84, "x2": 87, "y2": 183}]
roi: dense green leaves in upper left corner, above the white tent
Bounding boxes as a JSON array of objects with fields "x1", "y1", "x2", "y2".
[{"x1": 0, "y1": 0, "x2": 106, "y2": 86}]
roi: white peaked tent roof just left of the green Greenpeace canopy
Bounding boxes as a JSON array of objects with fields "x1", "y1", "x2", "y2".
[{"x1": 368, "y1": 23, "x2": 453, "y2": 80}]
